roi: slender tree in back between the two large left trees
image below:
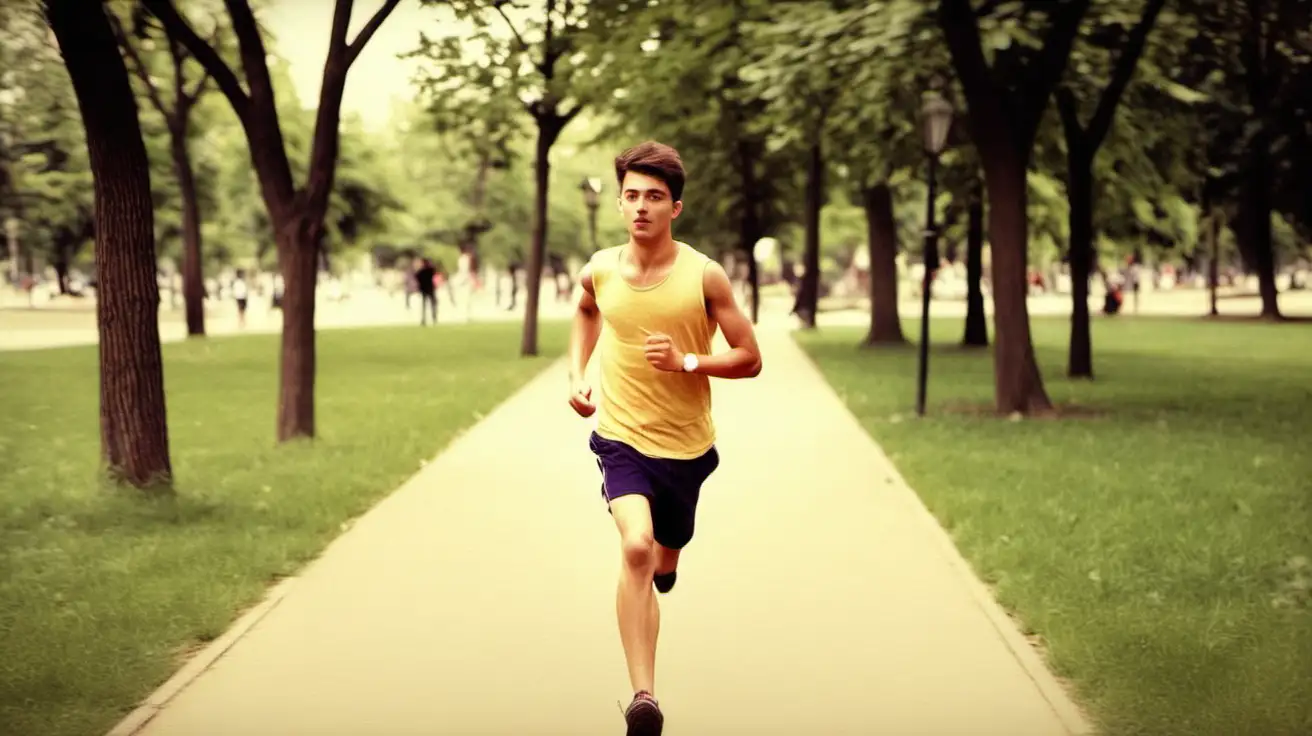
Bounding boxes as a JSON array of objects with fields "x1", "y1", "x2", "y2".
[{"x1": 110, "y1": 5, "x2": 218, "y2": 337}]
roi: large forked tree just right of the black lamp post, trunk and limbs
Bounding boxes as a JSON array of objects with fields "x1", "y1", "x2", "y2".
[{"x1": 938, "y1": 0, "x2": 1089, "y2": 413}]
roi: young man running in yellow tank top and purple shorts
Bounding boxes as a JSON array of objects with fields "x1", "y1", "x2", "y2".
[{"x1": 569, "y1": 142, "x2": 761, "y2": 736}]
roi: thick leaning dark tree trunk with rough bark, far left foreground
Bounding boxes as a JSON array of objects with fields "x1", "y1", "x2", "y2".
[{"x1": 46, "y1": 0, "x2": 173, "y2": 489}]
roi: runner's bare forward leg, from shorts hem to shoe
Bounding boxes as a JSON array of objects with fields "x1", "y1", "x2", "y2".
[{"x1": 610, "y1": 493, "x2": 660, "y2": 694}]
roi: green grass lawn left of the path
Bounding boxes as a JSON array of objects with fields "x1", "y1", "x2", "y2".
[{"x1": 0, "y1": 323, "x2": 567, "y2": 736}]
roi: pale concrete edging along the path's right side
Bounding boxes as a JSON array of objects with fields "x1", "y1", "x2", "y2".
[{"x1": 798, "y1": 345, "x2": 1096, "y2": 736}]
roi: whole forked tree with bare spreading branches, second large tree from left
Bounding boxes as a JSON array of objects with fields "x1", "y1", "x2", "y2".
[{"x1": 142, "y1": 0, "x2": 400, "y2": 441}]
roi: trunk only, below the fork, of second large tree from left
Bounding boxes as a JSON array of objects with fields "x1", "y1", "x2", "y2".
[{"x1": 276, "y1": 215, "x2": 323, "y2": 442}]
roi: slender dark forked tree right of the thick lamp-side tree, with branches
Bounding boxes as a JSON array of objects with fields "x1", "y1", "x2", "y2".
[{"x1": 1056, "y1": 0, "x2": 1166, "y2": 378}]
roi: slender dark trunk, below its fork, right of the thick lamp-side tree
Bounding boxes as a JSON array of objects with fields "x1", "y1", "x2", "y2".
[{"x1": 1067, "y1": 147, "x2": 1093, "y2": 378}]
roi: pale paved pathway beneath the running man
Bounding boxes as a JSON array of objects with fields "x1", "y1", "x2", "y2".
[{"x1": 119, "y1": 327, "x2": 1086, "y2": 736}]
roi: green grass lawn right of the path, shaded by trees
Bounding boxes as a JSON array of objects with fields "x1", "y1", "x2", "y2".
[{"x1": 799, "y1": 319, "x2": 1312, "y2": 736}]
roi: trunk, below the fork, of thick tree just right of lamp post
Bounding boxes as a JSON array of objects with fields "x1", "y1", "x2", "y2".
[{"x1": 981, "y1": 157, "x2": 1052, "y2": 415}]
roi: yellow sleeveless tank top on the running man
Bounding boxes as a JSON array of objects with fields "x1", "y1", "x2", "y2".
[{"x1": 590, "y1": 243, "x2": 715, "y2": 459}]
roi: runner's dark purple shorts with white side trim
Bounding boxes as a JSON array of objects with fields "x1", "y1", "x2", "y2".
[{"x1": 588, "y1": 432, "x2": 720, "y2": 550}]
